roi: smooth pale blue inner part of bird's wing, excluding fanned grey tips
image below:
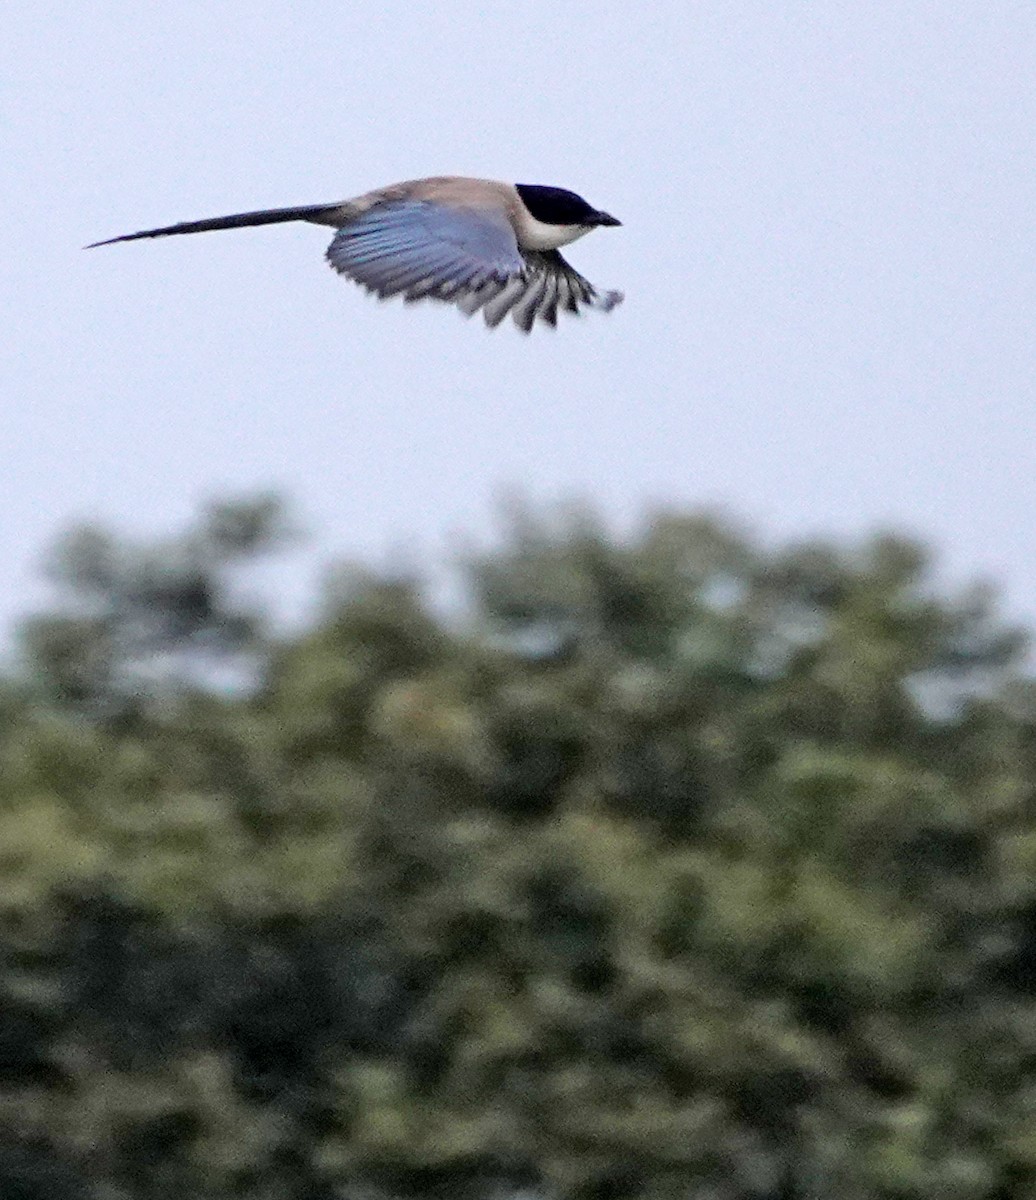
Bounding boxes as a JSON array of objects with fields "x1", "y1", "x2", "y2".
[{"x1": 328, "y1": 200, "x2": 525, "y2": 300}]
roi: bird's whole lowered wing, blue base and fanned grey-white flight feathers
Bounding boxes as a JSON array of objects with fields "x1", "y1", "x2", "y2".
[{"x1": 327, "y1": 199, "x2": 622, "y2": 332}]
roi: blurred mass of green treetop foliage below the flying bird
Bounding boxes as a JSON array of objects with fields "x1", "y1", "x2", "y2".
[{"x1": 0, "y1": 498, "x2": 1036, "y2": 1200}]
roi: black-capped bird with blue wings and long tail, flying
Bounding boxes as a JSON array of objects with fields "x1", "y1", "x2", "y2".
[{"x1": 86, "y1": 175, "x2": 623, "y2": 334}]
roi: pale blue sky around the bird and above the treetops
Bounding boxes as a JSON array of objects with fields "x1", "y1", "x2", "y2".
[{"x1": 0, "y1": 0, "x2": 1036, "y2": 630}]
